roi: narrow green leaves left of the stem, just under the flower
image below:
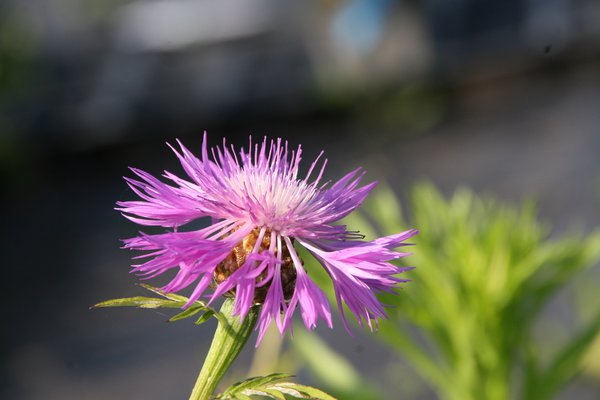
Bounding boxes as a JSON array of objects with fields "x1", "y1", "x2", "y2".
[{"x1": 92, "y1": 284, "x2": 224, "y2": 325}]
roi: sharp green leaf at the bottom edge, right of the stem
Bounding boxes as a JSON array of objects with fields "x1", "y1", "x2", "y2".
[{"x1": 216, "y1": 374, "x2": 335, "y2": 400}]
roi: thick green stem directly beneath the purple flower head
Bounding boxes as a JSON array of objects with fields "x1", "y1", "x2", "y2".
[{"x1": 190, "y1": 298, "x2": 260, "y2": 400}]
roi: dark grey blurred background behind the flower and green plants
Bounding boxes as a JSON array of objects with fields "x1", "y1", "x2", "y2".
[{"x1": 0, "y1": 0, "x2": 600, "y2": 400}]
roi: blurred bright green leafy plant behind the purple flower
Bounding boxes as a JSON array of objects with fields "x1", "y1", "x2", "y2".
[{"x1": 302, "y1": 184, "x2": 600, "y2": 400}]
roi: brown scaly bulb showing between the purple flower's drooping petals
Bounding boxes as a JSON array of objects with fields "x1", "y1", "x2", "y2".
[{"x1": 213, "y1": 228, "x2": 296, "y2": 303}]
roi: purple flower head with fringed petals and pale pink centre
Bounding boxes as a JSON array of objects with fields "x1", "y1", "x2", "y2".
[{"x1": 117, "y1": 134, "x2": 417, "y2": 344}]
